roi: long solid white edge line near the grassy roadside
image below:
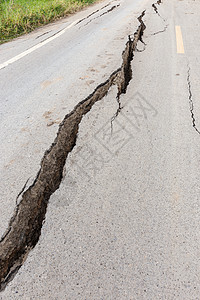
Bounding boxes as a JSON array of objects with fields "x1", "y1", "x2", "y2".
[{"x1": 0, "y1": 19, "x2": 80, "y2": 70}]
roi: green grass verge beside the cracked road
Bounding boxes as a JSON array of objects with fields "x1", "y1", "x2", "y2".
[{"x1": 0, "y1": 0, "x2": 97, "y2": 44}]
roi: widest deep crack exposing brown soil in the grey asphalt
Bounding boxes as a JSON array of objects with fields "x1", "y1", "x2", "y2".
[{"x1": 0, "y1": 11, "x2": 146, "y2": 291}]
